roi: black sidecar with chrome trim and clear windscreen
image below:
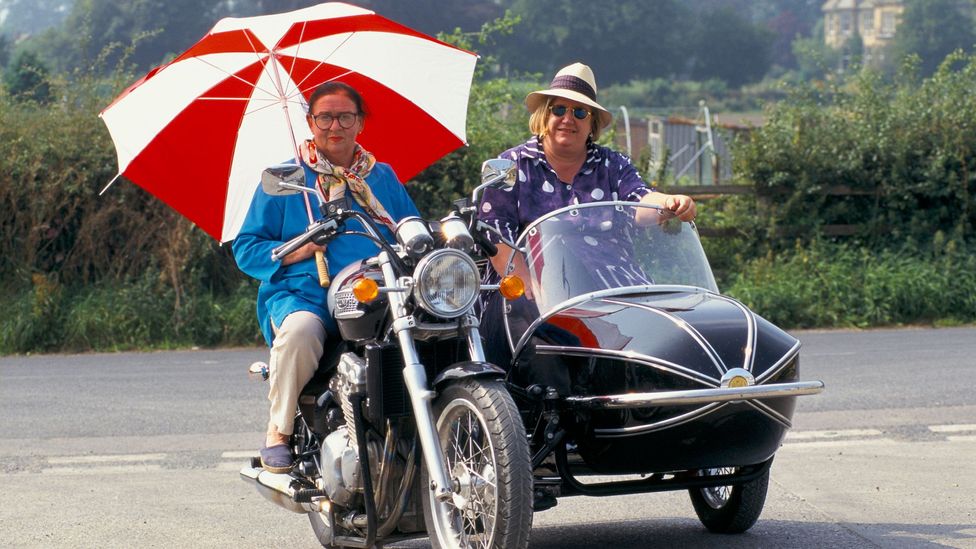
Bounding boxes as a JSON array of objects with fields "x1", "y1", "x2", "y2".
[{"x1": 503, "y1": 202, "x2": 823, "y2": 532}]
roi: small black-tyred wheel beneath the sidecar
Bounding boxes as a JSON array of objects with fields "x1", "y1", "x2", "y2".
[{"x1": 688, "y1": 468, "x2": 769, "y2": 534}]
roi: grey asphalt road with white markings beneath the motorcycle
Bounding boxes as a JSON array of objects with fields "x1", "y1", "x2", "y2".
[{"x1": 0, "y1": 328, "x2": 976, "y2": 549}]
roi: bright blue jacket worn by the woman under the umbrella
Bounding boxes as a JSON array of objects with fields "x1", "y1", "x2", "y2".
[{"x1": 233, "y1": 162, "x2": 420, "y2": 346}]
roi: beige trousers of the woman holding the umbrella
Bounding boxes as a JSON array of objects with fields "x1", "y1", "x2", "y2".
[{"x1": 268, "y1": 311, "x2": 325, "y2": 435}]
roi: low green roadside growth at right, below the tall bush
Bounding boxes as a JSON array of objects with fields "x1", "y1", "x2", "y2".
[{"x1": 723, "y1": 237, "x2": 976, "y2": 328}]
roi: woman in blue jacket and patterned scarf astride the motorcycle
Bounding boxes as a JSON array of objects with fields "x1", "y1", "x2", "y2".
[{"x1": 234, "y1": 81, "x2": 418, "y2": 473}]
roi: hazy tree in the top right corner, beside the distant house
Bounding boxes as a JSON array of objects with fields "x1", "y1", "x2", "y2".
[{"x1": 888, "y1": 0, "x2": 976, "y2": 75}]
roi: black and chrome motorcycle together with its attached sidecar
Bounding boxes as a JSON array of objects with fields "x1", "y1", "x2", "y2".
[{"x1": 241, "y1": 159, "x2": 823, "y2": 548}]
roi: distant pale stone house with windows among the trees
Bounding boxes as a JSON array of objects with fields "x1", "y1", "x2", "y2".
[{"x1": 821, "y1": 0, "x2": 905, "y2": 66}]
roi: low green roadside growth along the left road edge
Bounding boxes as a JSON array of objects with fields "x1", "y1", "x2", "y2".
[{"x1": 0, "y1": 272, "x2": 263, "y2": 354}]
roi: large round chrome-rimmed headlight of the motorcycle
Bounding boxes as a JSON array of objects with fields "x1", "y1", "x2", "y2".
[{"x1": 414, "y1": 249, "x2": 481, "y2": 318}]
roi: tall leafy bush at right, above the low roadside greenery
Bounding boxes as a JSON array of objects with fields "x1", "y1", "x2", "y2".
[{"x1": 734, "y1": 53, "x2": 976, "y2": 249}]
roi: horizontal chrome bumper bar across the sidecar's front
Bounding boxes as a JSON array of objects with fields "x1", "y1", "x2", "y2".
[{"x1": 564, "y1": 381, "x2": 824, "y2": 410}]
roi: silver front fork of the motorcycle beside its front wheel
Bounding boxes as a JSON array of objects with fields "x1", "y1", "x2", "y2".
[{"x1": 379, "y1": 252, "x2": 485, "y2": 502}]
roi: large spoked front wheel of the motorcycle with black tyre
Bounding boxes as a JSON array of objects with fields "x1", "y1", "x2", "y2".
[{"x1": 421, "y1": 379, "x2": 532, "y2": 549}]
